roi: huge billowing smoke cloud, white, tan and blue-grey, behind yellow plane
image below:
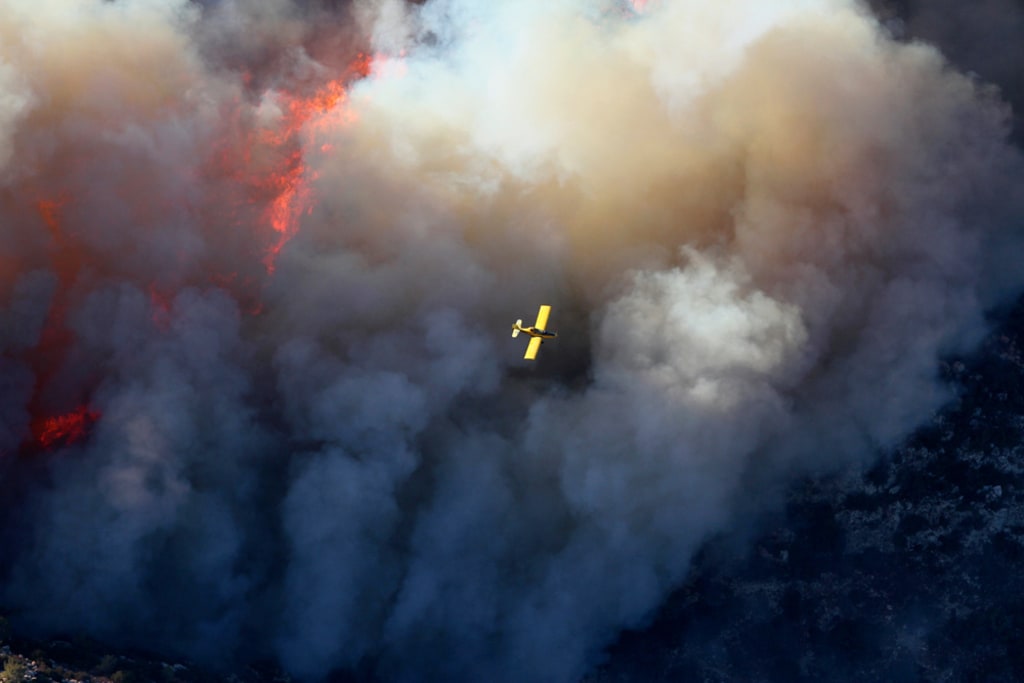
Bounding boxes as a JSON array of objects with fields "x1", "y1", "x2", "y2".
[{"x1": 0, "y1": 0, "x2": 1024, "y2": 681}]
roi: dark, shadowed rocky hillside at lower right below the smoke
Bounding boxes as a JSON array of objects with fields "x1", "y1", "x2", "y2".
[{"x1": 590, "y1": 309, "x2": 1024, "y2": 683}]
